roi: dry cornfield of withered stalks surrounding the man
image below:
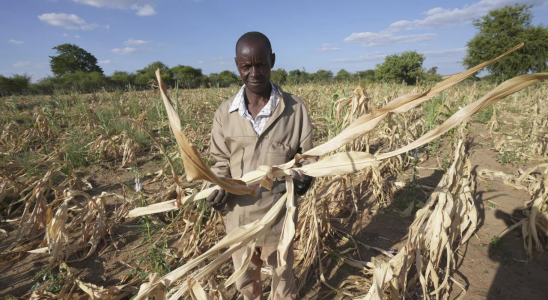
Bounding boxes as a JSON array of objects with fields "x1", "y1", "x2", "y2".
[{"x1": 0, "y1": 45, "x2": 548, "y2": 299}]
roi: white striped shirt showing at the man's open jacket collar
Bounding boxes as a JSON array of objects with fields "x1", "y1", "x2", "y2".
[{"x1": 228, "y1": 83, "x2": 280, "y2": 135}]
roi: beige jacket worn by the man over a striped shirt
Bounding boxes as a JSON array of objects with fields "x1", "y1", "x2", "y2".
[{"x1": 210, "y1": 86, "x2": 312, "y2": 246}]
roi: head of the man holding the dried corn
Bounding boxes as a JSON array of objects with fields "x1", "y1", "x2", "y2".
[{"x1": 234, "y1": 31, "x2": 276, "y2": 94}]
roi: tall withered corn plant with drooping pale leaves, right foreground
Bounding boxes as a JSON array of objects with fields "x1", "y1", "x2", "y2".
[{"x1": 359, "y1": 140, "x2": 478, "y2": 300}]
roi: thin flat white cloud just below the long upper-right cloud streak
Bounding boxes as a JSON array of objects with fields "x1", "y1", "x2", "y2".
[{"x1": 344, "y1": 31, "x2": 436, "y2": 47}]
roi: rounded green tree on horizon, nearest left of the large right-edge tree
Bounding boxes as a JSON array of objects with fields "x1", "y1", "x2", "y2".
[{"x1": 375, "y1": 51, "x2": 424, "y2": 84}]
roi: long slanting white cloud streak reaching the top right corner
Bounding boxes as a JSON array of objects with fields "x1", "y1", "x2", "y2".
[{"x1": 387, "y1": 0, "x2": 548, "y2": 32}]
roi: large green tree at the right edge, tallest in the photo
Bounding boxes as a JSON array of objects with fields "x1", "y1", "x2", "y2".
[{"x1": 463, "y1": 4, "x2": 548, "y2": 81}]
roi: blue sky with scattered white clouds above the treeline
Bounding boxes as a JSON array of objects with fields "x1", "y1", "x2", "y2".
[{"x1": 0, "y1": 0, "x2": 548, "y2": 81}]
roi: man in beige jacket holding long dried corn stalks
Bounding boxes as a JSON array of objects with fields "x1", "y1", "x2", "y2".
[{"x1": 207, "y1": 32, "x2": 312, "y2": 300}]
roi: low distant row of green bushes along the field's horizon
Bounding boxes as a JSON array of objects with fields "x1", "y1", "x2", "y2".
[{"x1": 0, "y1": 62, "x2": 441, "y2": 96}]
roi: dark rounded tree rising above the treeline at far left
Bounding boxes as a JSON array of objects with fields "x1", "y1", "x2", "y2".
[{"x1": 49, "y1": 44, "x2": 103, "y2": 76}]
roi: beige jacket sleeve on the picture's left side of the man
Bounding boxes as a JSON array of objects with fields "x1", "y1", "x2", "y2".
[{"x1": 209, "y1": 109, "x2": 231, "y2": 177}]
